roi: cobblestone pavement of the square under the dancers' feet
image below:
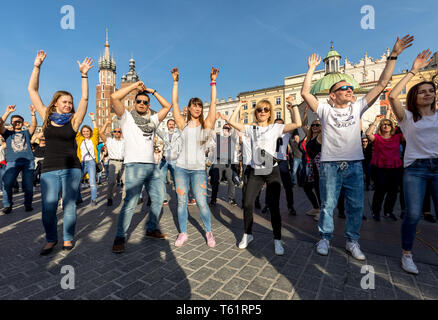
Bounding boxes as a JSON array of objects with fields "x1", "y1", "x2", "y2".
[{"x1": 0, "y1": 185, "x2": 438, "y2": 300}]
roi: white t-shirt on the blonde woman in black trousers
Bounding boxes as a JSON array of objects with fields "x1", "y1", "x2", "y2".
[{"x1": 245, "y1": 123, "x2": 284, "y2": 169}]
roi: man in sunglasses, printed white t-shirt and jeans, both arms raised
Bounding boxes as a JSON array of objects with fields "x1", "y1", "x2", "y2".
[{"x1": 301, "y1": 35, "x2": 413, "y2": 260}]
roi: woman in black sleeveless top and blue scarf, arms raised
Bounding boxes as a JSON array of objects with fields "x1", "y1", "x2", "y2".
[{"x1": 28, "y1": 50, "x2": 93, "y2": 255}]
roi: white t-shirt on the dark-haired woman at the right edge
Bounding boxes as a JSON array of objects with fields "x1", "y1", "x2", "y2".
[{"x1": 399, "y1": 110, "x2": 438, "y2": 168}]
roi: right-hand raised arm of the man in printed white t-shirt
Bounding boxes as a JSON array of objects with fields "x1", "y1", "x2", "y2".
[{"x1": 365, "y1": 35, "x2": 414, "y2": 106}]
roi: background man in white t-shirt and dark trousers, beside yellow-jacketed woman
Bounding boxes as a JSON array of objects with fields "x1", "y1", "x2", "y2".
[{"x1": 99, "y1": 120, "x2": 125, "y2": 207}]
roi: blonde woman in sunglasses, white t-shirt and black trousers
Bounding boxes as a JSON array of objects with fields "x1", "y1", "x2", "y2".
[{"x1": 228, "y1": 100, "x2": 301, "y2": 255}]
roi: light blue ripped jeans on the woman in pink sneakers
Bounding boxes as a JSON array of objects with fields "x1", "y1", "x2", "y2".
[{"x1": 175, "y1": 167, "x2": 211, "y2": 233}]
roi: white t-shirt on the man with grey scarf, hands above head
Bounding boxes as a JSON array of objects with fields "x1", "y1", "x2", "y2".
[{"x1": 119, "y1": 110, "x2": 159, "y2": 163}]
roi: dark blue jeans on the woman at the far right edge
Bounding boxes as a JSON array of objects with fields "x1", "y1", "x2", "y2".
[{"x1": 401, "y1": 159, "x2": 438, "y2": 251}]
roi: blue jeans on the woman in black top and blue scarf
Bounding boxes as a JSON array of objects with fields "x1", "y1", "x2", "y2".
[{"x1": 41, "y1": 168, "x2": 81, "y2": 242}]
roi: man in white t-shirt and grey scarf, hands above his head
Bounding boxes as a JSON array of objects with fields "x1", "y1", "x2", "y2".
[{"x1": 111, "y1": 81, "x2": 171, "y2": 253}]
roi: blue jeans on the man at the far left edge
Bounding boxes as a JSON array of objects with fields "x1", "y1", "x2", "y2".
[{"x1": 3, "y1": 159, "x2": 35, "y2": 208}]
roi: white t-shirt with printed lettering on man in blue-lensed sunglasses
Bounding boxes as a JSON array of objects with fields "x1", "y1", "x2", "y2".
[{"x1": 316, "y1": 97, "x2": 368, "y2": 161}]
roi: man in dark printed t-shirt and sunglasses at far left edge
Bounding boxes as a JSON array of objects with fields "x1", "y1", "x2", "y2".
[{"x1": 0, "y1": 106, "x2": 37, "y2": 214}]
